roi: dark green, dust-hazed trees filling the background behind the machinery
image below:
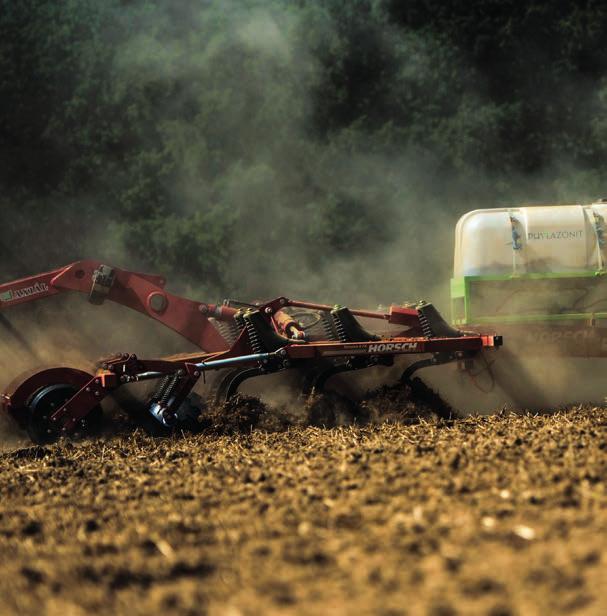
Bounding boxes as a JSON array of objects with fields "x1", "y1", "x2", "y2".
[{"x1": 0, "y1": 0, "x2": 607, "y2": 299}]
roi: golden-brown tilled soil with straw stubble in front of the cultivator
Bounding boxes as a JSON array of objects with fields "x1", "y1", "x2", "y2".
[{"x1": 0, "y1": 408, "x2": 607, "y2": 616}]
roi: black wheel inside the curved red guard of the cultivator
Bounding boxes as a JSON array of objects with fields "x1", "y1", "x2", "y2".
[{"x1": 27, "y1": 383, "x2": 103, "y2": 445}]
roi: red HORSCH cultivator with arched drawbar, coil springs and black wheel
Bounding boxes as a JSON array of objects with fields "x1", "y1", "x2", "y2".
[{"x1": 0, "y1": 261, "x2": 501, "y2": 442}]
